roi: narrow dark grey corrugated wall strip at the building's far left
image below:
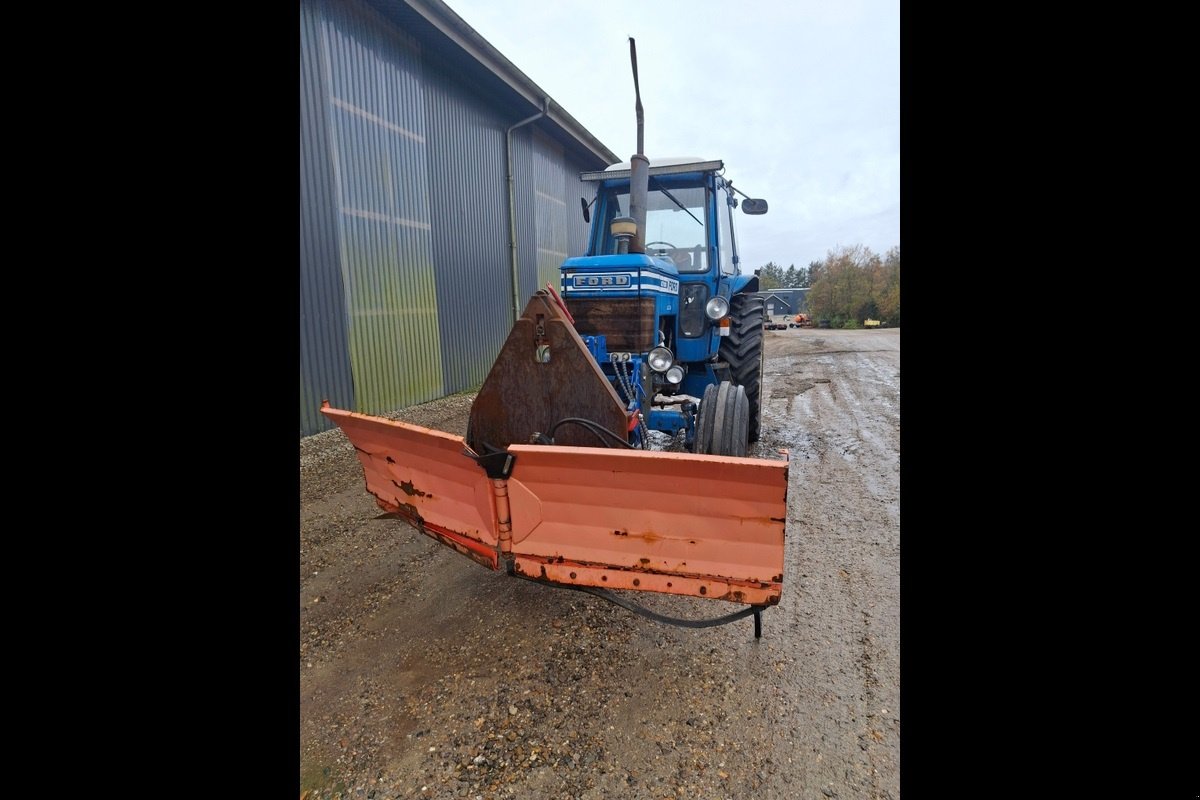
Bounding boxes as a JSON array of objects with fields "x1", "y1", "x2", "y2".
[{"x1": 300, "y1": 2, "x2": 354, "y2": 435}]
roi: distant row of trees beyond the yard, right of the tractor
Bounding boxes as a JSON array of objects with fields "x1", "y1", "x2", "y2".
[{"x1": 757, "y1": 245, "x2": 900, "y2": 327}]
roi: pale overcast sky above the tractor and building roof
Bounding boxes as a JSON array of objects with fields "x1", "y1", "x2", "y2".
[{"x1": 445, "y1": 0, "x2": 900, "y2": 270}]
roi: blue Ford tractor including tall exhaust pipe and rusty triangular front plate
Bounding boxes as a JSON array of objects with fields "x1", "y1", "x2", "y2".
[{"x1": 467, "y1": 40, "x2": 767, "y2": 458}]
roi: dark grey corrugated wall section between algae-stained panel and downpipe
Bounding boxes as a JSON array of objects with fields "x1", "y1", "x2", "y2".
[{"x1": 425, "y1": 54, "x2": 513, "y2": 395}]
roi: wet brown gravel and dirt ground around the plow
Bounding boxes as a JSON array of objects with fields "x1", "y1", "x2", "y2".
[{"x1": 299, "y1": 329, "x2": 900, "y2": 800}]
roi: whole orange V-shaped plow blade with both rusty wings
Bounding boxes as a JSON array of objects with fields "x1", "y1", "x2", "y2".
[{"x1": 322, "y1": 404, "x2": 788, "y2": 606}]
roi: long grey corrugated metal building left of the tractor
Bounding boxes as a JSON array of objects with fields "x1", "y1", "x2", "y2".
[{"x1": 300, "y1": 0, "x2": 632, "y2": 435}]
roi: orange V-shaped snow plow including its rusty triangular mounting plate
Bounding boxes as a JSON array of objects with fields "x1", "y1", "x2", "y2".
[{"x1": 322, "y1": 291, "x2": 788, "y2": 636}]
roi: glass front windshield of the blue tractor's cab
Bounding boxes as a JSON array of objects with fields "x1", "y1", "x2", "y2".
[{"x1": 596, "y1": 183, "x2": 708, "y2": 272}]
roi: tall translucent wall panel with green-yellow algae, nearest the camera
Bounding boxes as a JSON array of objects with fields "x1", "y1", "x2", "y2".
[{"x1": 322, "y1": 2, "x2": 443, "y2": 414}]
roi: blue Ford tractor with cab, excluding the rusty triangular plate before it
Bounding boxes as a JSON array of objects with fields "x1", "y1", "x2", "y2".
[{"x1": 562, "y1": 158, "x2": 767, "y2": 456}]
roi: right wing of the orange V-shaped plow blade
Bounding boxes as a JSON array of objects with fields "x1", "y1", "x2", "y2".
[{"x1": 509, "y1": 445, "x2": 787, "y2": 604}]
